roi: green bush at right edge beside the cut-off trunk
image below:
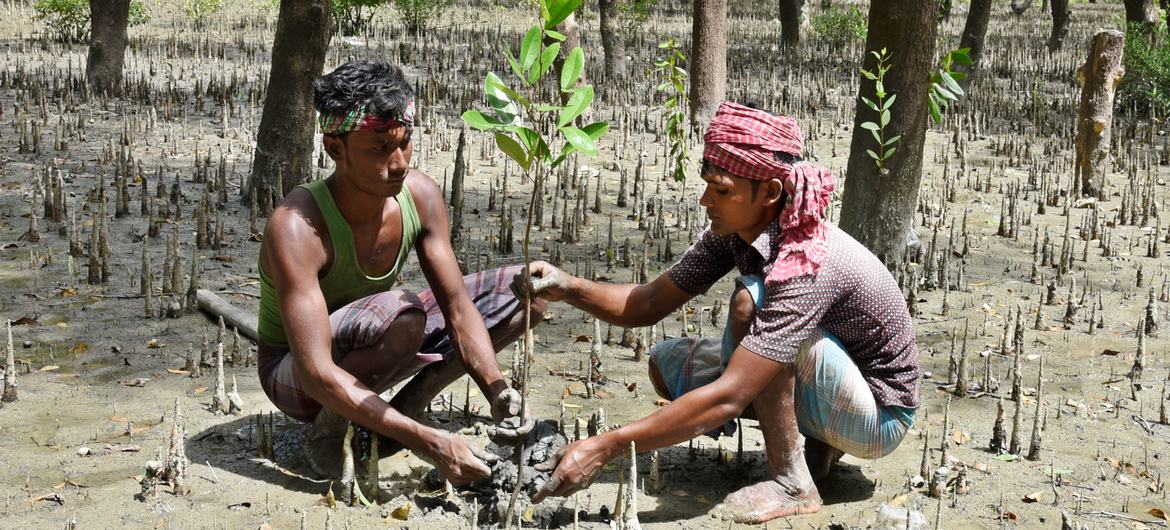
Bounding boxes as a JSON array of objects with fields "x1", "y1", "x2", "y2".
[{"x1": 1117, "y1": 23, "x2": 1170, "y2": 116}]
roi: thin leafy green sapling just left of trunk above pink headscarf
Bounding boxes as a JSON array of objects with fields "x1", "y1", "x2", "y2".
[{"x1": 654, "y1": 39, "x2": 690, "y2": 183}]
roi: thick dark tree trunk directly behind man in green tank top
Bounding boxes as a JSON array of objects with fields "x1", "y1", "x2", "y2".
[{"x1": 245, "y1": 0, "x2": 332, "y2": 204}]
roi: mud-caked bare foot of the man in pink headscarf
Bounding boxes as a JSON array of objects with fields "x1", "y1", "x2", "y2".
[{"x1": 722, "y1": 475, "x2": 821, "y2": 524}]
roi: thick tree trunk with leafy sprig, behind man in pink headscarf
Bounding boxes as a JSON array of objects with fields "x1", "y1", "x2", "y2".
[{"x1": 839, "y1": 0, "x2": 938, "y2": 263}]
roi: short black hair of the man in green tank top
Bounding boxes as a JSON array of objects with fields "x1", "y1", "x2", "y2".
[{"x1": 312, "y1": 61, "x2": 414, "y2": 137}]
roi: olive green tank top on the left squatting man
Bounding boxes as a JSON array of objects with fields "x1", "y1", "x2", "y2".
[{"x1": 256, "y1": 180, "x2": 421, "y2": 346}]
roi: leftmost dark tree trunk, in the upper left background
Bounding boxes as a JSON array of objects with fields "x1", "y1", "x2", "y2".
[{"x1": 85, "y1": 0, "x2": 130, "y2": 95}]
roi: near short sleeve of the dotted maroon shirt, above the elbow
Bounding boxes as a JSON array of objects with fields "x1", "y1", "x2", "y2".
[{"x1": 739, "y1": 275, "x2": 835, "y2": 363}]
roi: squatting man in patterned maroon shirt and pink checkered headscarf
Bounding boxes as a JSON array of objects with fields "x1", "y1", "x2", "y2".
[{"x1": 512, "y1": 102, "x2": 918, "y2": 523}]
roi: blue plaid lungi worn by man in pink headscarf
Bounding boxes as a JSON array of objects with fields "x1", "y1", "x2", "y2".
[{"x1": 651, "y1": 276, "x2": 915, "y2": 459}]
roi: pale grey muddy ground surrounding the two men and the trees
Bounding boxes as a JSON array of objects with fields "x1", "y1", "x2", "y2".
[{"x1": 0, "y1": 0, "x2": 1170, "y2": 529}]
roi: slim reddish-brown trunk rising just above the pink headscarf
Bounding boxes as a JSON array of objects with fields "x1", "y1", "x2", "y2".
[{"x1": 690, "y1": 0, "x2": 728, "y2": 131}]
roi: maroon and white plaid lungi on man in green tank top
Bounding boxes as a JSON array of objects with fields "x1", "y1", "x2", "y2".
[{"x1": 259, "y1": 266, "x2": 524, "y2": 421}]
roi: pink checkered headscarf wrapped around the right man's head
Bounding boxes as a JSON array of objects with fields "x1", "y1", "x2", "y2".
[{"x1": 703, "y1": 102, "x2": 837, "y2": 283}]
